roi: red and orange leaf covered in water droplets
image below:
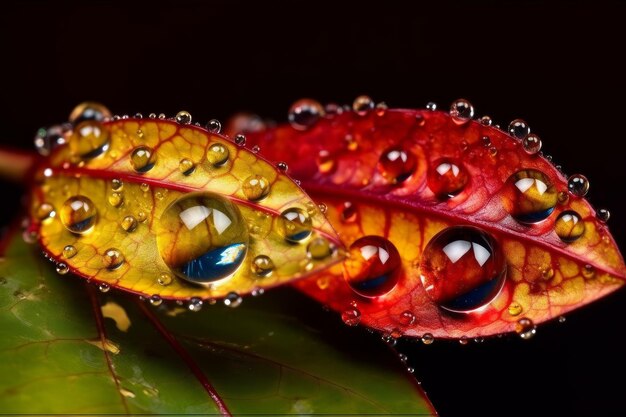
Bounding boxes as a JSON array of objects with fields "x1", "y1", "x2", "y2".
[{"x1": 244, "y1": 103, "x2": 626, "y2": 337}]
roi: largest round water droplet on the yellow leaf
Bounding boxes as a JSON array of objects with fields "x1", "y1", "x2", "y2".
[{"x1": 156, "y1": 193, "x2": 249, "y2": 284}]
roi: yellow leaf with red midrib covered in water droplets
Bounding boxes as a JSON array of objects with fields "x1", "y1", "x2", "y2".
[{"x1": 29, "y1": 112, "x2": 341, "y2": 299}]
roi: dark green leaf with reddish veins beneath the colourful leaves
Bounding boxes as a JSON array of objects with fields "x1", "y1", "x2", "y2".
[{"x1": 0, "y1": 229, "x2": 435, "y2": 415}]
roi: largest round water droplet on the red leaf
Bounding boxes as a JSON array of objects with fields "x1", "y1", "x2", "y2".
[{"x1": 419, "y1": 226, "x2": 506, "y2": 313}]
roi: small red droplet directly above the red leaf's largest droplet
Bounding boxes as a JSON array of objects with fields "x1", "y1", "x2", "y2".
[{"x1": 426, "y1": 158, "x2": 469, "y2": 200}]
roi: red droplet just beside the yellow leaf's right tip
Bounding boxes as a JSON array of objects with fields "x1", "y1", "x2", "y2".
[{"x1": 343, "y1": 236, "x2": 401, "y2": 297}]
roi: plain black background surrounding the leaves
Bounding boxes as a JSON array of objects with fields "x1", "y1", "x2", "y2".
[{"x1": 0, "y1": 0, "x2": 626, "y2": 416}]
